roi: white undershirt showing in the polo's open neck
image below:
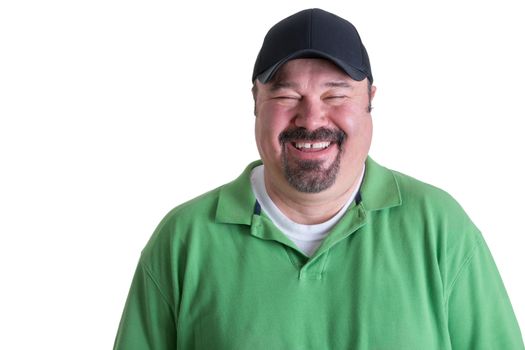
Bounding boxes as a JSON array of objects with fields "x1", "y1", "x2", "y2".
[{"x1": 250, "y1": 165, "x2": 365, "y2": 256}]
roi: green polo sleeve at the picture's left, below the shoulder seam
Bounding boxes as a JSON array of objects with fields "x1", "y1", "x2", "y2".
[{"x1": 113, "y1": 261, "x2": 177, "y2": 350}]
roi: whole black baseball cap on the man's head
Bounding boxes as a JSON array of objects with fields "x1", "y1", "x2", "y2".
[{"x1": 252, "y1": 9, "x2": 373, "y2": 84}]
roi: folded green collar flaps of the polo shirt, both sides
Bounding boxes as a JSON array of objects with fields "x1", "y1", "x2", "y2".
[{"x1": 215, "y1": 157, "x2": 402, "y2": 225}]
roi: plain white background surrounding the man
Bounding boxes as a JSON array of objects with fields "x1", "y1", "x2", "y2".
[{"x1": 0, "y1": 0, "x2": 525, "y2": 349}]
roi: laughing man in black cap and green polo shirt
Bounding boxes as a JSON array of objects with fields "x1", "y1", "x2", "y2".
[{"x1": 115, "y1": 9, "x2": 524, "y2": 350}]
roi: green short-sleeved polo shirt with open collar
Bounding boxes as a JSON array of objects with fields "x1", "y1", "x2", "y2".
[{"x1": 114, "y1": 159, "x2": 524, "y2": 350}]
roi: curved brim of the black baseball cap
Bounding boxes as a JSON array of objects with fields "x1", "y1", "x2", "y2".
[{"x1": 256, "y1": 49, "x2": 367, "y2": 84}]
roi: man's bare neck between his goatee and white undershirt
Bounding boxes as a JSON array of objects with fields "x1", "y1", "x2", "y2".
[{"x1": 264, "y1": 168, "x2": 363, "y2": 225}]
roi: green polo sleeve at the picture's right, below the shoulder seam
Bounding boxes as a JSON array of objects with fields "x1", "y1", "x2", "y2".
[{"x1": 447, "y1": 235, "x2": 524, "y2": 350}]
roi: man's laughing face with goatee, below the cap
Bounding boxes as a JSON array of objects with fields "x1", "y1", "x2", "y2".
[{"x1": 255, "y1": 59, "x2": 375, "y2": 195}]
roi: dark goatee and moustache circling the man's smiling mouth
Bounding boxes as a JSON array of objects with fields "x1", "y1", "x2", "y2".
[{"x1": 279, "y1": 128, "x2": 346, "y2": 193}]
